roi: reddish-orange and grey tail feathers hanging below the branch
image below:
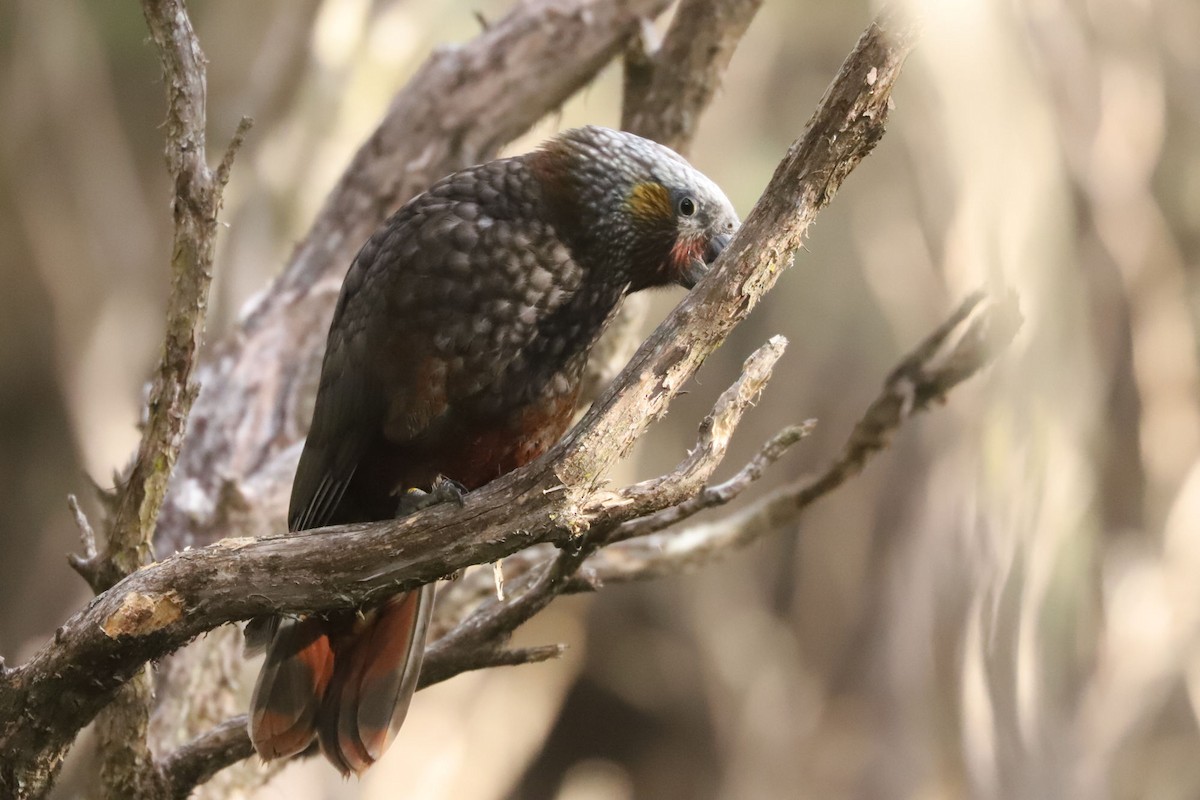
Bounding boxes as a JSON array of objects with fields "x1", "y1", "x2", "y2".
[{"x1": 250, "y1": 584, "x2": 433, "y2": 775}]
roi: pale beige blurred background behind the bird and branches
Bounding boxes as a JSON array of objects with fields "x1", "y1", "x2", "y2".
[{"x1": 0, "y1": 0, "x2": 1200, "y2": 800}]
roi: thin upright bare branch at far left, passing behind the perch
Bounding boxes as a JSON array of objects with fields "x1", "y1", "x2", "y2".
[{"x1": 70, "y1": 0, "x2": 250, "y2": 798}]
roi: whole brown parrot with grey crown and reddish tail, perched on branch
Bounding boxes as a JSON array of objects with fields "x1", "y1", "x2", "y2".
[{"x1": 247, "y1": 127, "x2": 738, "y2": 774}]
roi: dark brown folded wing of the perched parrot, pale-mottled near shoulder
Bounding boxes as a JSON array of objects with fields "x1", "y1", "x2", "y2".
[{"x1": 288, "y1": 160, "x2": 581, "y2": 530}]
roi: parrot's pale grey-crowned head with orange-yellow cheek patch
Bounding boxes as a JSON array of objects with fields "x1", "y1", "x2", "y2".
[{"x1": 533, "y1": 126, "x2": 739, "y2": 291}]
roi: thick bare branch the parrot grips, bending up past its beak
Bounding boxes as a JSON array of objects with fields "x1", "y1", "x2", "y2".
[{"x1": 0, "y1": 7, "x2": 914, "y2": 800}]
